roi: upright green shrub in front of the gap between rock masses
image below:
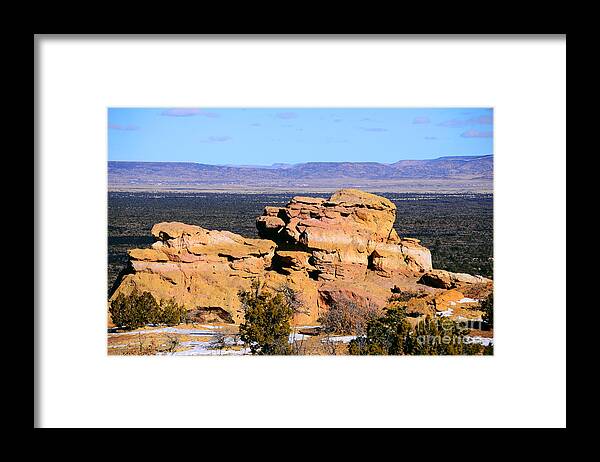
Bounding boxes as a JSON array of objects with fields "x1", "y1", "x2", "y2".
[{"x1": 239, "y1": 282, "x2": 293, "y2": 355}]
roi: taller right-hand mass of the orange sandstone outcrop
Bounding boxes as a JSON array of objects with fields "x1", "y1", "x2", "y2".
[{"x1": 256, "y1": 189, "x2": 431, "y2": 281}]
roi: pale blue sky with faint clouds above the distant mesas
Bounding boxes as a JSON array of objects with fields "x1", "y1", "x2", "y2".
[{"x1": 108, "y1": 108, "x2": 493, "y2": 165}]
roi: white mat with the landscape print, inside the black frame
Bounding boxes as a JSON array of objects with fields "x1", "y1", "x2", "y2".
[{"x1": 34, "y1": 34, "x2": 568, "y2": 435}]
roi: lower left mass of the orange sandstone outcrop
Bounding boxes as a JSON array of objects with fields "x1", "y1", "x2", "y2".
[{"x1": 111, "y1": 222, "x2": 284, "y2": 321}]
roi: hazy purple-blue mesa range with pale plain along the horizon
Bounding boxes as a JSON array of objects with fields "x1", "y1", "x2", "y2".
[{"x1": 108, "y1": 155, "x2": 493, "y2": 190}]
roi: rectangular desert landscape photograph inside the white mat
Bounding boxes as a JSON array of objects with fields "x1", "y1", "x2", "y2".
[{"x1": 106, "y1": 105, "x2": 494, "y2": 361}]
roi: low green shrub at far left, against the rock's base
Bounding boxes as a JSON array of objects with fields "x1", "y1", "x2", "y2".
[{"x1": 108, "y1": 288, "x2": 186, "y2": 330}]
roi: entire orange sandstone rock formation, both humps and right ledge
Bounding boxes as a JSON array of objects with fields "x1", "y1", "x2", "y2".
[{"x1": 110, "y1": 189, "x2": 492, "y2": 325}]
